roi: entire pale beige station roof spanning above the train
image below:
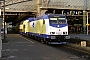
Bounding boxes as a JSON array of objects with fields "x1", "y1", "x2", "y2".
[{"x1": 0, "y1": 0, "x2": 90, "y2": 24}]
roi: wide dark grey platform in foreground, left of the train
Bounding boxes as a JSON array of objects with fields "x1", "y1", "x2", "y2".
[{"x1": 2, "y1": 34, "x2": 82, "y2": 60}]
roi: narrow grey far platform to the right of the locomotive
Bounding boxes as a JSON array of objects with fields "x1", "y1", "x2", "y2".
[{"x1": 69, "y1": 34, "x2": 90, "y2": 41}]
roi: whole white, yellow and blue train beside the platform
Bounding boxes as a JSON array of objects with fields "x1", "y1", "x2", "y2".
[{"x1": 20, "y1": 14, "x2": 70, "y2": 44}]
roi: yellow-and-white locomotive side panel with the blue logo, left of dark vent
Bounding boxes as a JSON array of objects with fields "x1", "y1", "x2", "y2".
[{"x1": 29, "y1": 20, "x2": 42, "y2": 34}]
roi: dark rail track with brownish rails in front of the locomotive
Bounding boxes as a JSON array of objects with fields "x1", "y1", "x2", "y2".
[{"x1": 50, "y1": 44, "x2": 90, "y2": 60}]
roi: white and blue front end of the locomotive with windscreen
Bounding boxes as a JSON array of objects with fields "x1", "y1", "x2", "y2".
[{"x1": 48, "y1": 14, "x2": 70, "y2": 44}]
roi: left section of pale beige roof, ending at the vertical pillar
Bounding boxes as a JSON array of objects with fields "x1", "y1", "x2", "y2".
[{"x1": 1, "y1": 0, "x2": 36, "y2": 12}]
